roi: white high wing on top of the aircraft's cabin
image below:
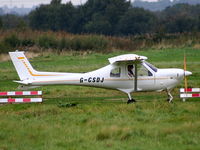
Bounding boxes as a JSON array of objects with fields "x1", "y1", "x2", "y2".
[{"x1": 108, "y1": 54, "x2": 147, "y2": 64}]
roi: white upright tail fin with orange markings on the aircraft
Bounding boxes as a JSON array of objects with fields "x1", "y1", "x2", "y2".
[{"x1": 9, "y1": 51, "x2": 37, "y2": 80}]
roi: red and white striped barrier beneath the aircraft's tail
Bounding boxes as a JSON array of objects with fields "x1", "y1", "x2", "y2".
[{"x1": 0, "y1": 91, "x2": 42, "y2": 103}]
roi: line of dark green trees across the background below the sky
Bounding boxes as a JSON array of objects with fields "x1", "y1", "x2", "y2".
[{"x1": 0, "y1": 0, "x2": 200, "y2": 36}]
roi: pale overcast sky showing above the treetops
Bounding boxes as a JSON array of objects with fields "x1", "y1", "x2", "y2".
[{"x1": 0, "y1": 0, "x2": 162, "y2": 7}]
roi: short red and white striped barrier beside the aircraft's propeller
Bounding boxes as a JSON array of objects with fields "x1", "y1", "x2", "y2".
[{"x1": 180, "y1": 88, "x2": 200, "y2": 101}]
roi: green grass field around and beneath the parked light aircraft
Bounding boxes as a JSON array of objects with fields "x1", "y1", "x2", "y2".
[{"x1": 0, "y1": 48, "x2": 200, "y2": 150}]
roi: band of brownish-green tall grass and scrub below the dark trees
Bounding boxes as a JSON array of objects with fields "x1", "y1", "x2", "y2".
[{"x1": 0, "y1": 30, "x2": 200, "y2": 53}]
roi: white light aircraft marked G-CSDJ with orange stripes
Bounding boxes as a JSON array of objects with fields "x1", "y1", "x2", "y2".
[{"x1": 9, "y1": 51, "x2": 192, "y2": 103}]
